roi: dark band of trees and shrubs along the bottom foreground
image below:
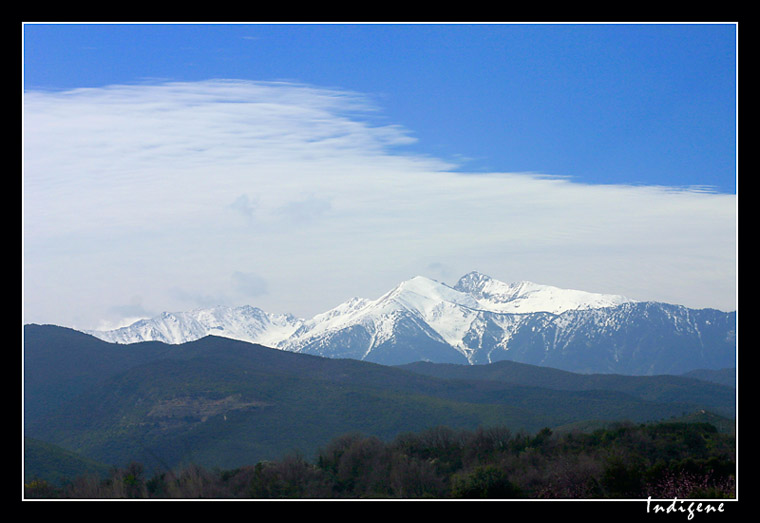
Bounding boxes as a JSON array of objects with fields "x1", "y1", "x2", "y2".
[{"x1": 25, "y1": 422, "x2": 736, "y2": 499}]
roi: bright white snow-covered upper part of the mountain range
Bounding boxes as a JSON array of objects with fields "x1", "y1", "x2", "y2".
[{"x1": 84, "y1": 271, "x2": 630, "y2": 351}]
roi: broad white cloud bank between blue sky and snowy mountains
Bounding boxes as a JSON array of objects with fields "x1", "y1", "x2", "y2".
[{"x1": 23, "y1": 81, "x2": 736, "y2": 328}]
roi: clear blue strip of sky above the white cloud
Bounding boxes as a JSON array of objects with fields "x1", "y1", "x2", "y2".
[{"x1": 24, "y1": 24, "x2": 736, "y2": 192}]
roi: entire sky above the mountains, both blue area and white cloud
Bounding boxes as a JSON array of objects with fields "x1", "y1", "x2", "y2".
[{"x1": 23, "y1": 24, "x2": 737, "y2": 325}]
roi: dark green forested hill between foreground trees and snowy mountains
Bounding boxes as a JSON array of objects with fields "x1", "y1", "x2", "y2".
[{"x1": 24, "y1": 325, "x2": 732, "y2": 470}]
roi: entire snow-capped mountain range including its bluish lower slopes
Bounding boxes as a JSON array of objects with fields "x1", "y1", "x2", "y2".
[{"x1": 84, "y1": 272, "x2": 736, "y2": 374}]
